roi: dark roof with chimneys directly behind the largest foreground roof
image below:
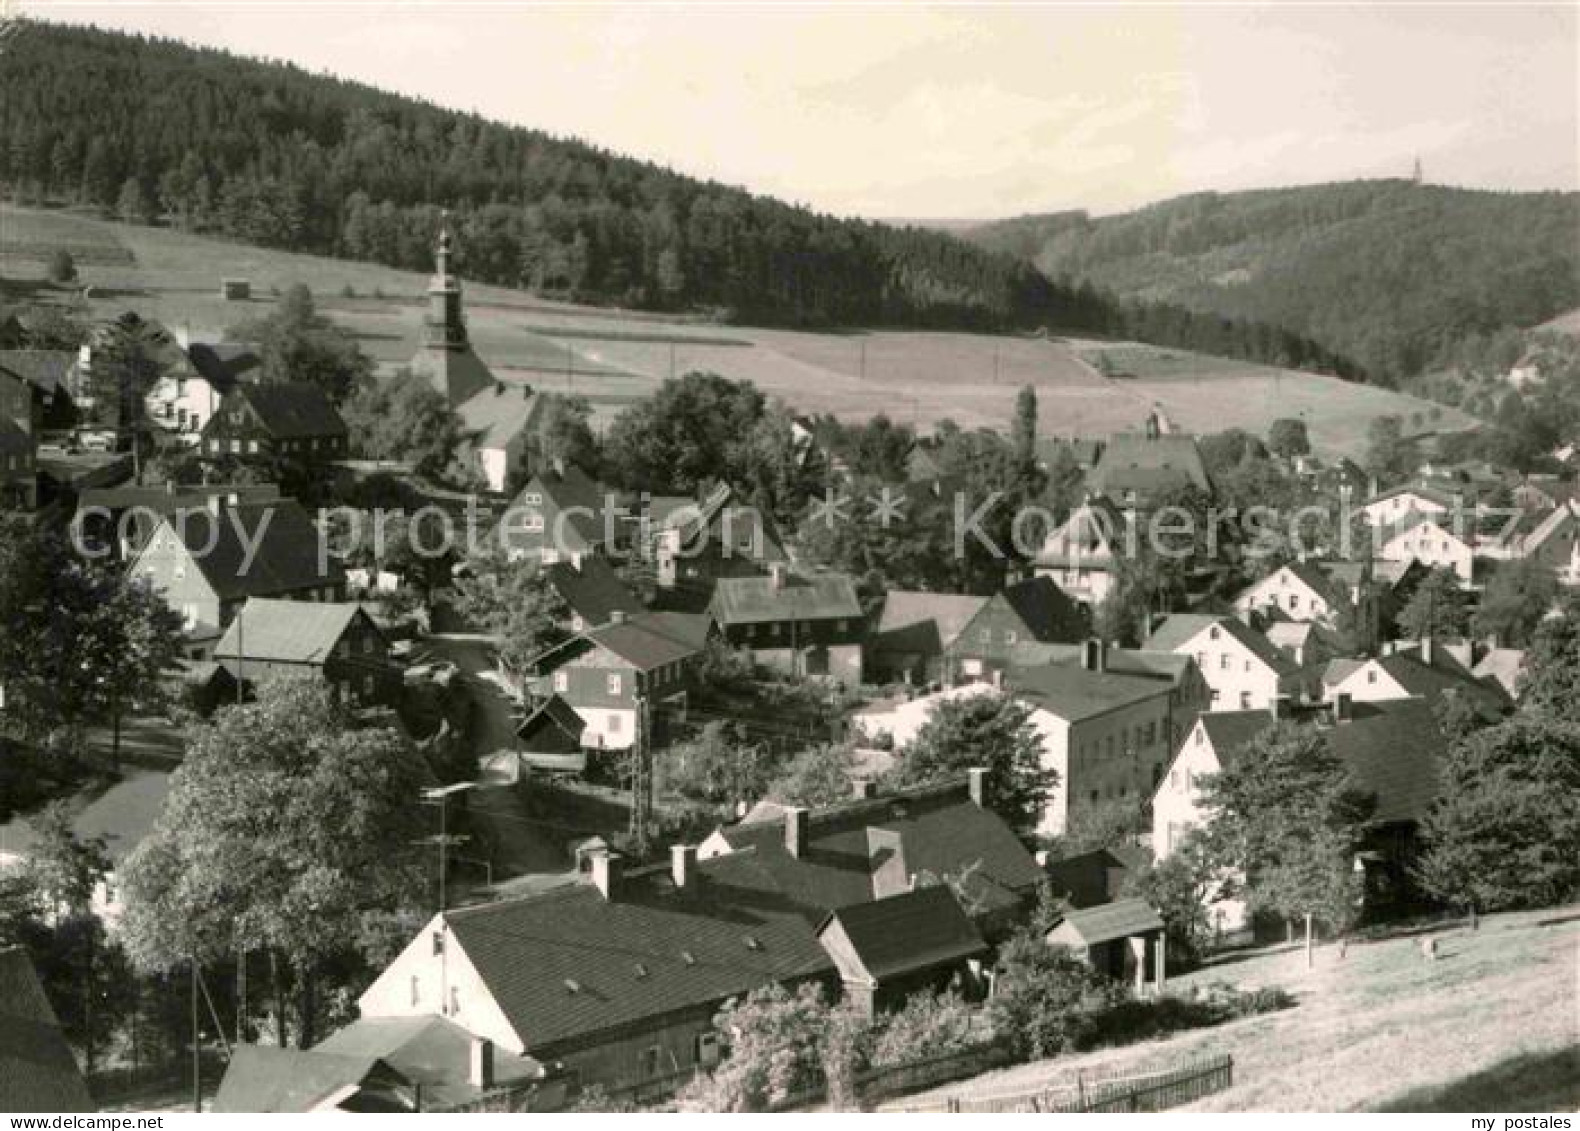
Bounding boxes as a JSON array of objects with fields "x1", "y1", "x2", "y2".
[{"x1": 719, "y1": 780, "x2": 1041, "y2": 922}]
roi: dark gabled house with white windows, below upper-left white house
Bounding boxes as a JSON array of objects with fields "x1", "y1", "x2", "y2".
[{"x1": 202, "y1": 381, "x2": 348, "y2": 463}]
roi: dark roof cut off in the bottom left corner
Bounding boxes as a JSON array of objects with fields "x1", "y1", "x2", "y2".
[{"x1": 0, "y1": 946, "x2": 98, "y2": 1112}]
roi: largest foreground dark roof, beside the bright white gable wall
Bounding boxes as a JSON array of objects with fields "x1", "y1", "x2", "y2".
[{"x1": 444, "y1": 853, "x2": 834, "y2": 1058}]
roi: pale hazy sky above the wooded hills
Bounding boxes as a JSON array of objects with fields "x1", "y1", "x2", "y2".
[{"x1": 27, "y1": 0, "x2": 1580, "y2": 220}]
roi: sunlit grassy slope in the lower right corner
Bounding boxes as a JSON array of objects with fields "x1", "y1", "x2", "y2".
[{"x1": 893, "y1": 907, "x2": 1580, "y2": 1112}]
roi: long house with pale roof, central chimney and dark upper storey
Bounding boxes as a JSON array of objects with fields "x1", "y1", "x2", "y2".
[{"x1": 708, "y1": 562, "x2": 866, "y2": 684}]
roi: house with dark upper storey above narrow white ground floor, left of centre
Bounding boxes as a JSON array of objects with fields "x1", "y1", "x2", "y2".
[{"x1": 532, "y1": 613, "x2": 711, "y2": 750}]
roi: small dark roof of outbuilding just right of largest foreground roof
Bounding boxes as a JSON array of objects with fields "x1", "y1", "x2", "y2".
[{"x1": 818, "y1": 883, "x2": 988, "y2": 979}]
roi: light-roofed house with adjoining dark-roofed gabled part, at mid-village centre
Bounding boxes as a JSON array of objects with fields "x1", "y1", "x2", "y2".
[{"x1": 867, "y1": 577, "x2": 1089, "y2": 682}]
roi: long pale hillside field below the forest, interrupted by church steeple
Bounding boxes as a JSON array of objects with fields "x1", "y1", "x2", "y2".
[{"x1": 0, "y1": 205, "x2": 1471, "y2": 457}]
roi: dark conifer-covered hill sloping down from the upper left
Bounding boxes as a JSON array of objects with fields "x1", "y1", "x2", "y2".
[{"x1": 0, "y1": 24, "x2": 1354, "y2": 376}]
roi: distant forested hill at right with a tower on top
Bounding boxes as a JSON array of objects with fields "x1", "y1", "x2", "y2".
[{"x1": 964, "y1": 180, "x2": 1580, "y2": 381}]
